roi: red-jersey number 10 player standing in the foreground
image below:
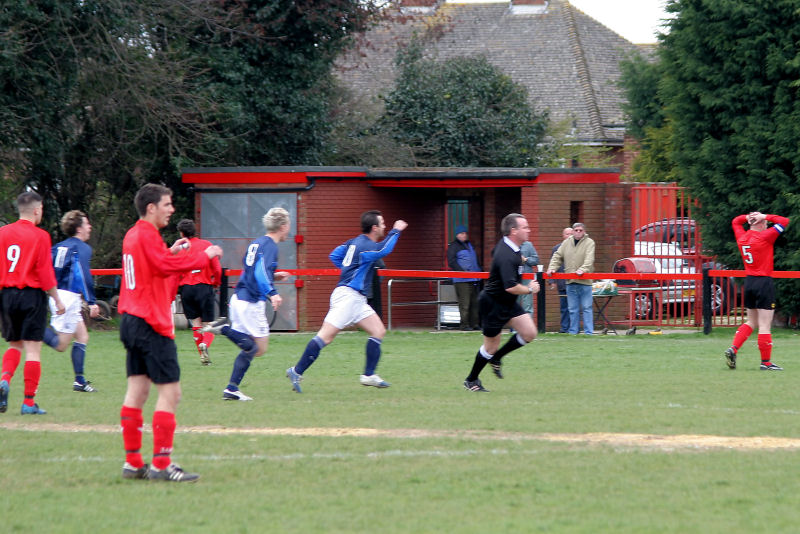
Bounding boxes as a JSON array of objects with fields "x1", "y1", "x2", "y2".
[{"x1": 119, "y1": 184, "x2": 222, "y2": 482}]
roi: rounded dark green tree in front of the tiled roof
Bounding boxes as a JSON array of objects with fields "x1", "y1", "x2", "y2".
[{"x1": 383, "y1": 41, "x2": 548, "y2": 167}]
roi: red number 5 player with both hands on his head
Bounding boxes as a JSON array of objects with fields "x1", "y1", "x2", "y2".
[{"x1": 725, "y1": 211, "x2": 789, "y2": 371}]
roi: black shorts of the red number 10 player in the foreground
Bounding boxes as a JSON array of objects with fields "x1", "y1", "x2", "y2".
[{"x1": 119, "y1": 313, "x2": 181, "y2": 384}]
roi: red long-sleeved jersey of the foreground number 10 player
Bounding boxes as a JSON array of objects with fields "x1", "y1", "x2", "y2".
[{"x1": 119, "y1": 219, "x2": 210, "y2": 339}]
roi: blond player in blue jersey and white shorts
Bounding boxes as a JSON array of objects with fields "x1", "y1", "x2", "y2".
[{"x1": 202, "y1": 208, "x2": 290, "y2": 401}]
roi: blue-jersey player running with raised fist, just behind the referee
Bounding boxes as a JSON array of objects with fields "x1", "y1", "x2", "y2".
[{"x1": 286, "y1": 210, "x2": 408, "y2": 393}]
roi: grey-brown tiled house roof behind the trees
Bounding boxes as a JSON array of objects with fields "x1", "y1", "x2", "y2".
[{"x1": 338, "y1": 0, "x2": 641, "y2": 144}]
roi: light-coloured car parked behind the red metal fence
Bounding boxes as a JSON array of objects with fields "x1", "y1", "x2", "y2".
[{"x1": 612, "y1": 241, "x2": 730, "y2": 319}]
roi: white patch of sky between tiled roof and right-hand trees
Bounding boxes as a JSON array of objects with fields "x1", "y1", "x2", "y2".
[{"x1": 569, "y1": 0, "x2": 667, "y2": 44}]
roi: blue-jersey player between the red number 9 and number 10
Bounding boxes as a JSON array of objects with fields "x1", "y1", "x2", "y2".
[{"x1": 44, "y1": 210, "x2": 100, "y2": 393}]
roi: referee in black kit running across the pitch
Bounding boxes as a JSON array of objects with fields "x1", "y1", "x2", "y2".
[{"x1": 464, "y1": 213, "x2": 539, "y2": 392}]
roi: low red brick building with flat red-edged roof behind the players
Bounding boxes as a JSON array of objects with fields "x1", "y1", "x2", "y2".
[{"x1": 183, "y1": 167, "x2": 632, "y2": 330}]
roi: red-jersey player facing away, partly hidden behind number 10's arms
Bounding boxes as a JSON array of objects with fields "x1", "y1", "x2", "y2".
[{"x1": 178, "y1": 219, "x2": 222, "y2": 365}]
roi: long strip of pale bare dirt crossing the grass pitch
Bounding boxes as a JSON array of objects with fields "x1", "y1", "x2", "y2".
[{"x1": 0, "y1": 421, "x2": 800, "y2": 451}]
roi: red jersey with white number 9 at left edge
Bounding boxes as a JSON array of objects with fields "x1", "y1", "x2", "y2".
[{"x1": 0, "y1": 219, "x2": 56, "y2": 291}]
